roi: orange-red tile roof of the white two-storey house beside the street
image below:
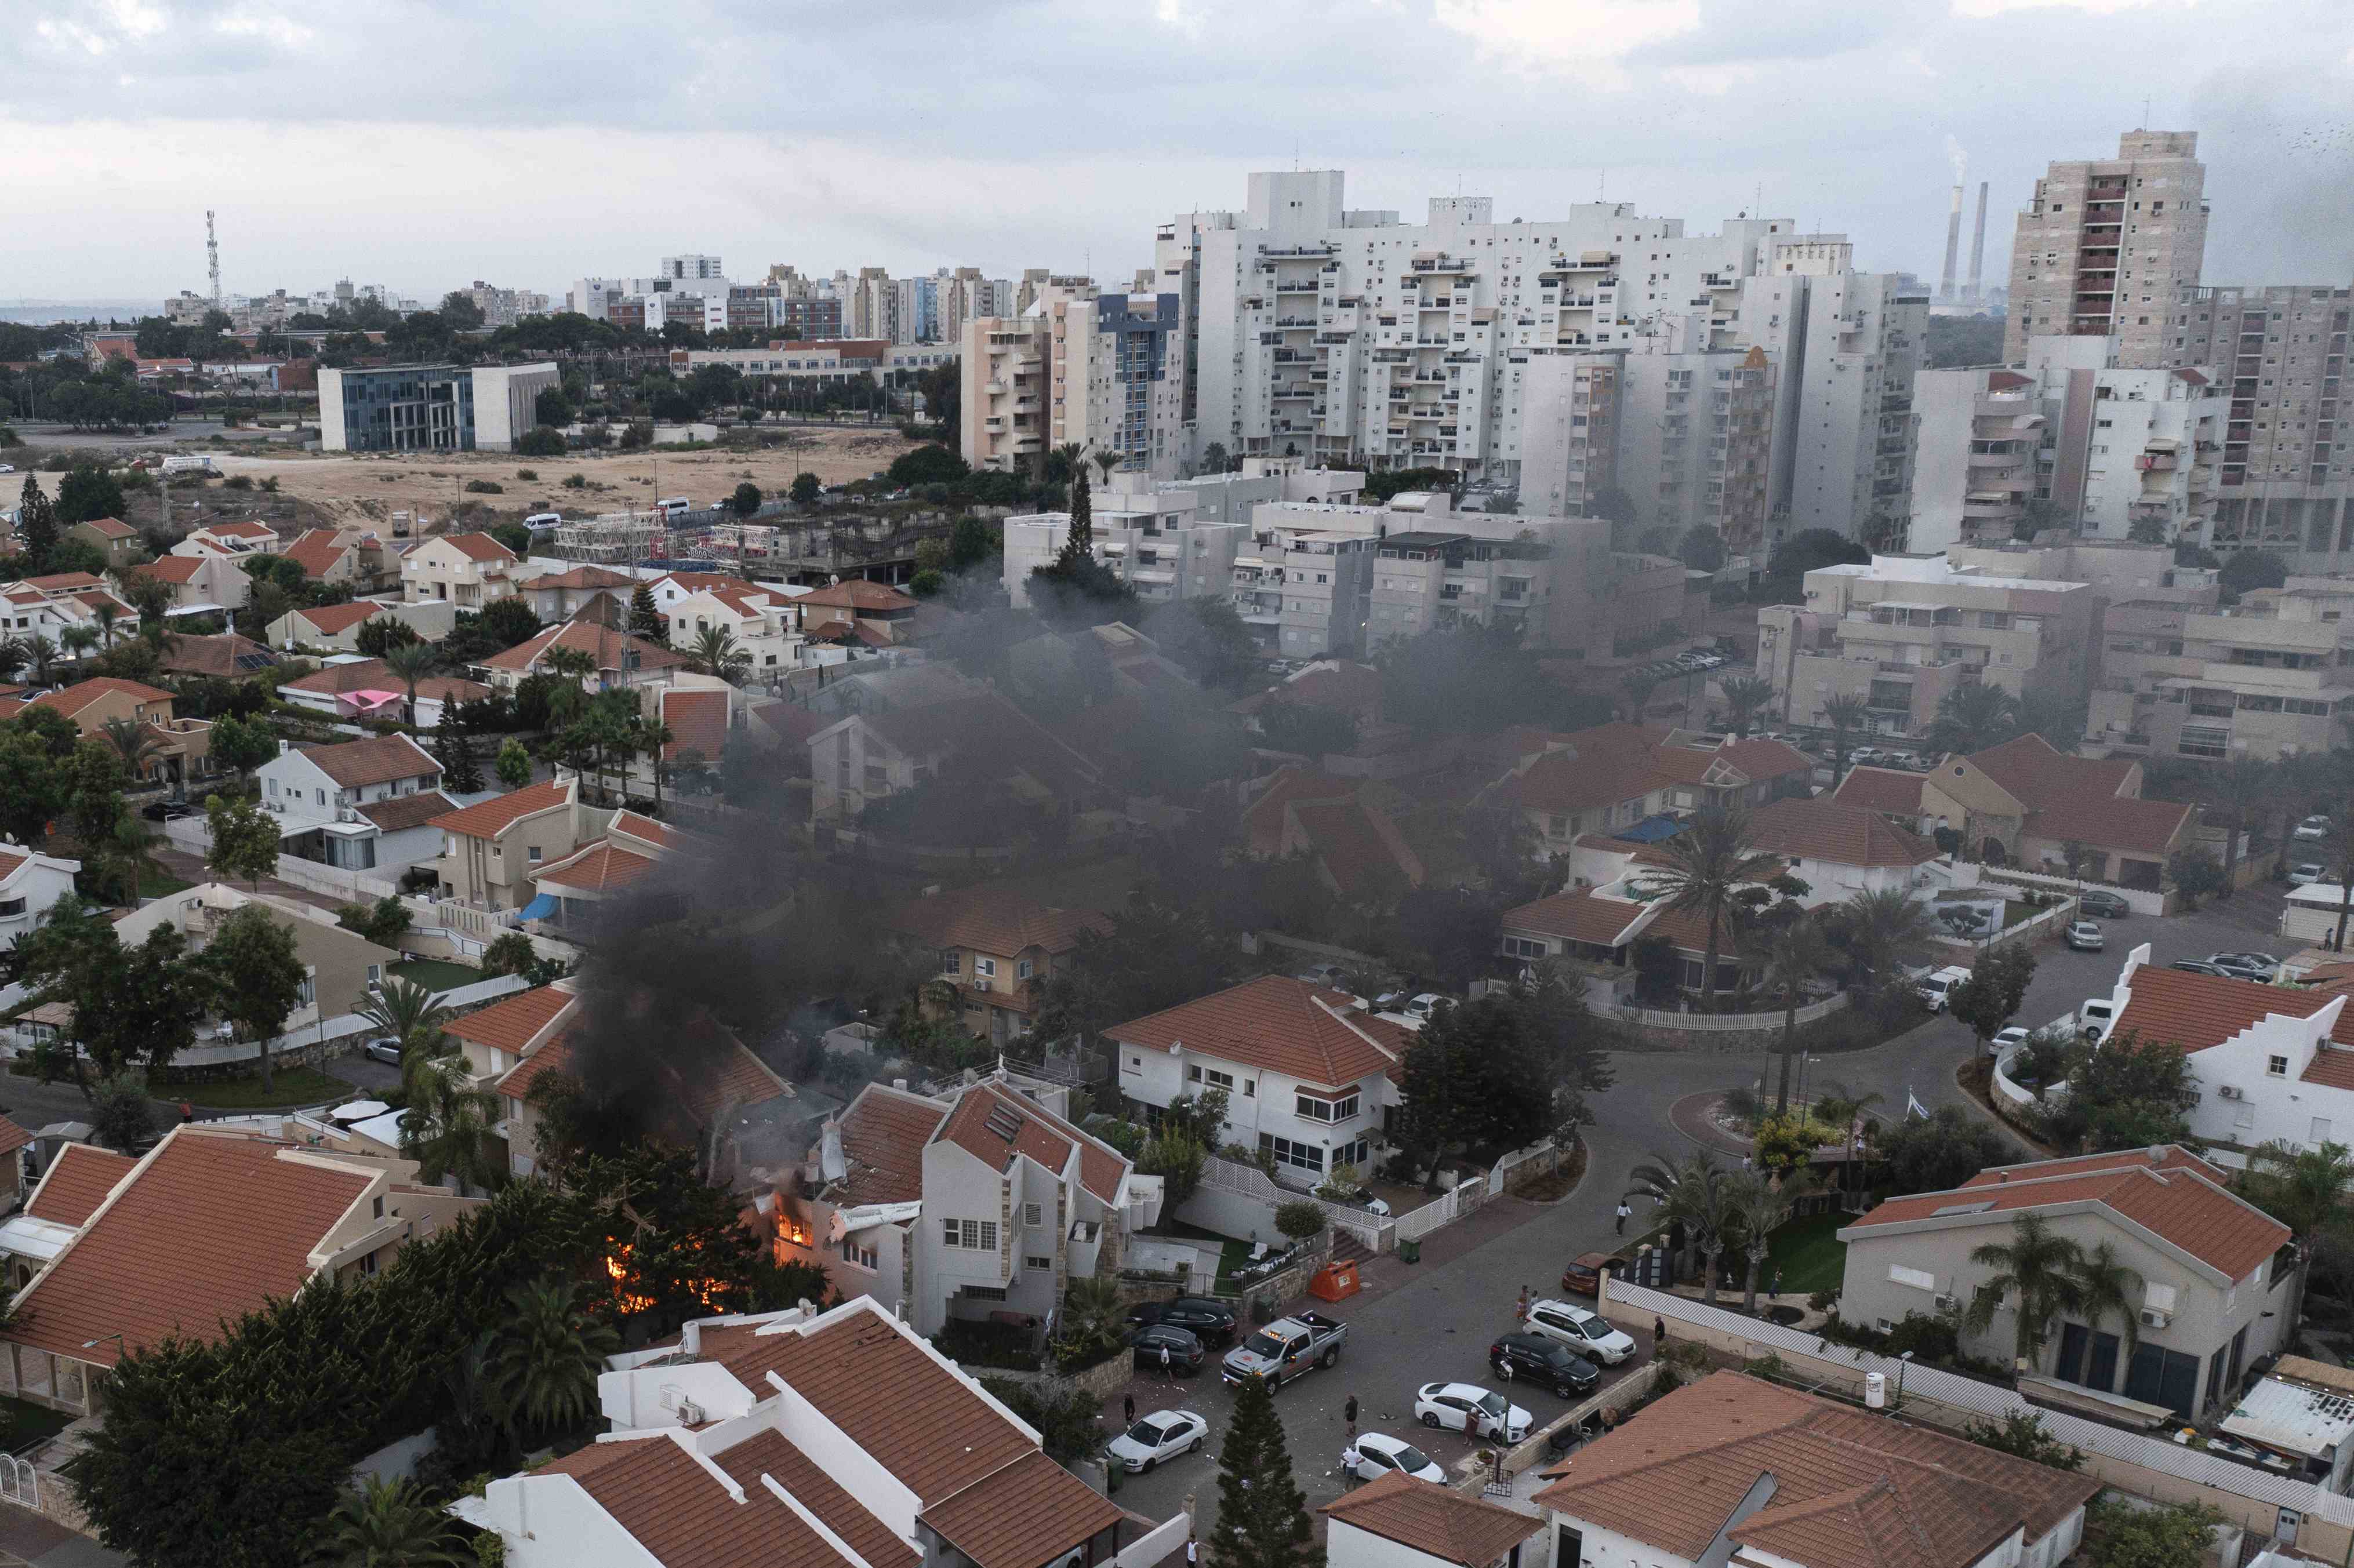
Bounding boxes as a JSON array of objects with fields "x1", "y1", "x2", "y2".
[{"x1": 1106, "y1": 974, "x2": 1415, "y2": 1087}]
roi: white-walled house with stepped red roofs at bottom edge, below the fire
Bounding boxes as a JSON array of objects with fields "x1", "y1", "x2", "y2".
[{"x1": 459, "y1": 1297, "x2": 1158, "y2": 1568}]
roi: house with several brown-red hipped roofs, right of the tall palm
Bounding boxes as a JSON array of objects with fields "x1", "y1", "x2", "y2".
[{"x1": 1839, "y1": 734, "x2": 2199, "y2": 892}]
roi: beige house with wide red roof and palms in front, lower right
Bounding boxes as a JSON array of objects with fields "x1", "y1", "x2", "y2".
[{"x1": 1839, "y1": 1134, "x2": 2288, "y2": 1424}]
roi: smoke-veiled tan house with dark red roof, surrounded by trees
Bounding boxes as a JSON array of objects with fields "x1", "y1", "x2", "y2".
[{"x1": 885, "y1": 885, "x2": 1111, "y2": 1045}]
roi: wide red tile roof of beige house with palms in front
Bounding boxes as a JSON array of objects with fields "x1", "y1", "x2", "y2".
[{"x1": 1841, "y1": 1144, "x2": 2288, "y2": 1280}]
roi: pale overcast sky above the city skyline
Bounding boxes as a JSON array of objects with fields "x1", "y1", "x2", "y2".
[{"x1": 0, "y1": 0, "x2": 2354, "y2": 299}]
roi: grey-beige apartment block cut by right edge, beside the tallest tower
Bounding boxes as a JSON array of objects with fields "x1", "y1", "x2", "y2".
[{"x1": 2161, "y1": 285, "x2": 2354, "y2": 572}]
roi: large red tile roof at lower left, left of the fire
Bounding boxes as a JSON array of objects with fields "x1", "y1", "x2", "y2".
[{"x1": 5, "y1": 1127, "x2": 369, "y2": 1366}]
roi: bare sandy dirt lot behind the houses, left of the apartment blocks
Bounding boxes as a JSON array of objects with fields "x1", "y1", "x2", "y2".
[{"x1": 7, "y1": 428, "x2": 916, "y2": 532}]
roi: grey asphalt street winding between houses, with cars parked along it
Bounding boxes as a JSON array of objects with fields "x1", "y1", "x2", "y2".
[{"x1": 1104, "y1": 887, "x2": 2290, "y2": 1533}]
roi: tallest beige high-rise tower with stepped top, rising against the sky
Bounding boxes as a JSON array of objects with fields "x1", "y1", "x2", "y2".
[{"x1": 2003, "y1": 129, "x2": 2208, "y2": 370}]
